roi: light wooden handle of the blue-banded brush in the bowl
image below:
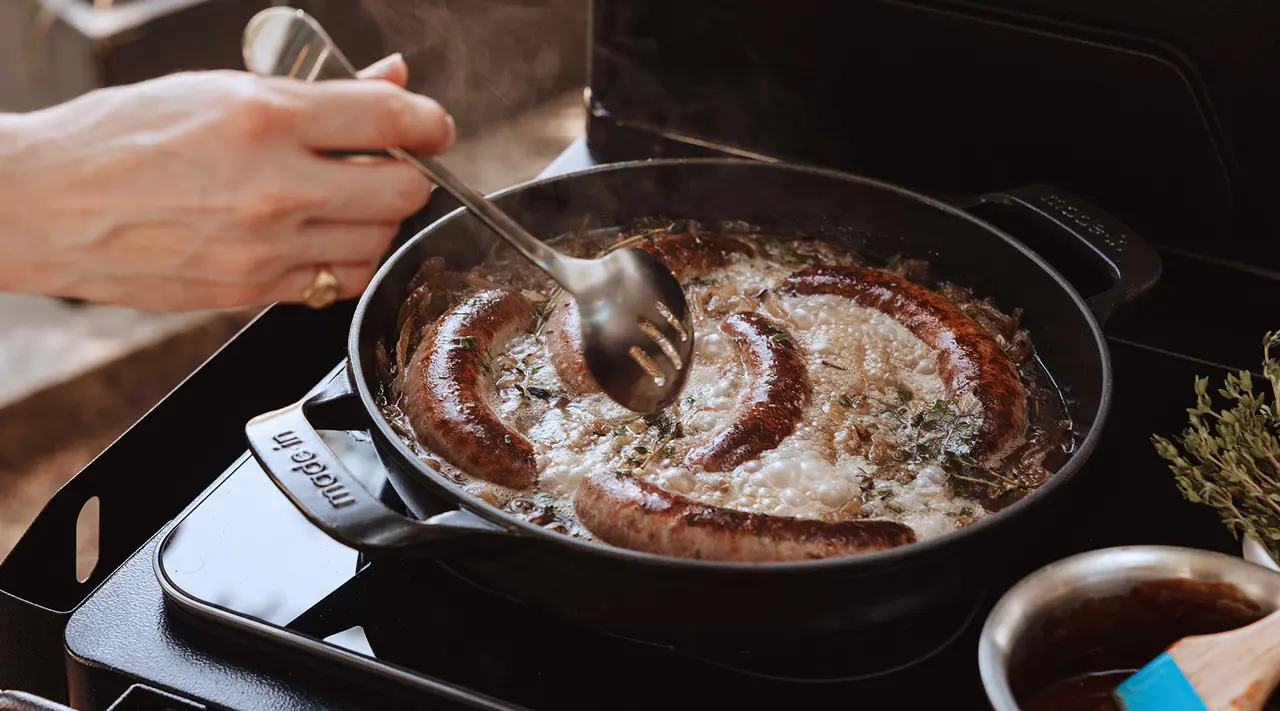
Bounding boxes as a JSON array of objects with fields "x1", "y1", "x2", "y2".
[{"x1": 1169, "y1": 611, "x2": 1280, "y2": 711}]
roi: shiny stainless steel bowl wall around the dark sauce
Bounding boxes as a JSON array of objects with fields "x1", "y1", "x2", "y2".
[{"x1": 978, "y1": 546, "x2": 1280, "y2": 711}]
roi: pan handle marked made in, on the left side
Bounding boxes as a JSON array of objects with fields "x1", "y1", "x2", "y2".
[{"x1": 244, "y1": 369, "x2": 511, "y2": 556}]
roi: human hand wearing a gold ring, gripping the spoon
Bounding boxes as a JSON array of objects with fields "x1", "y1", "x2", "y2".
[{"x1": 0, "y1": 55, "x2": 454, "y2": 311}]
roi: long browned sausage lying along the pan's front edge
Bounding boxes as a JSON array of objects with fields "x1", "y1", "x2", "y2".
[{"x1": 573, "y1": 471, "x2": 915, "y2": 562}]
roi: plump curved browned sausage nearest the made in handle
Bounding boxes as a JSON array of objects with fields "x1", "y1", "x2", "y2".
[{"x1": 403, "y1": 290, "x2": 538, "y2": 489}]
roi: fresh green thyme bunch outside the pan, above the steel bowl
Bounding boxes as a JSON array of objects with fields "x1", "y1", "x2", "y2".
[{"x1": 1151, "y1": 332, "x2": 1280, "y2": 559}]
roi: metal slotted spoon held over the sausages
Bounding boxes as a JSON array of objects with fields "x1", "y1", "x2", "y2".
[{"x1": 243, "y1": 6, "x2": 694, "y2": 413}]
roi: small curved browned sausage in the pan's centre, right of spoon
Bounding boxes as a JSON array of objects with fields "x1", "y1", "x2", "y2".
[{"x1": 685, "y1": 313, "x2": 813, "y2": 471}]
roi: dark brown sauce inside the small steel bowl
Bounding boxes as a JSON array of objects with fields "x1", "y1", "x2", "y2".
[{"x1": 1010, "y1": 579, "x2": 1280, "y2": 711}]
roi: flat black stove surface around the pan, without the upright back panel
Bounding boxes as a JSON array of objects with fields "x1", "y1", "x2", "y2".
[{"x1": 0, "y1": 142, "x2": 1264, "y2": 708}]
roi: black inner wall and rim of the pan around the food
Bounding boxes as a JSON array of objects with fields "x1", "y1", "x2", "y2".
[{"x1": 351, "y1": 161, "x2": 1108, "y2": 568}]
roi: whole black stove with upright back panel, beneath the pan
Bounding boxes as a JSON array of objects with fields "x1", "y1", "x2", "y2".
[{"x1": 0, "y1": 0, "x2": 1280, "y2": 708}]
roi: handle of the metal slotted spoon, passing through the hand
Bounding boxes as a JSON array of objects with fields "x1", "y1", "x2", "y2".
[{"x1": 243, "y1": 6, "x2": 570, "y2": 287}]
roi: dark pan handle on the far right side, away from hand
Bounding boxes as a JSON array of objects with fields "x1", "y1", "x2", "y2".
[{"x1": 955, "y1": 186, "x2": 1161, "y2": 324}]
